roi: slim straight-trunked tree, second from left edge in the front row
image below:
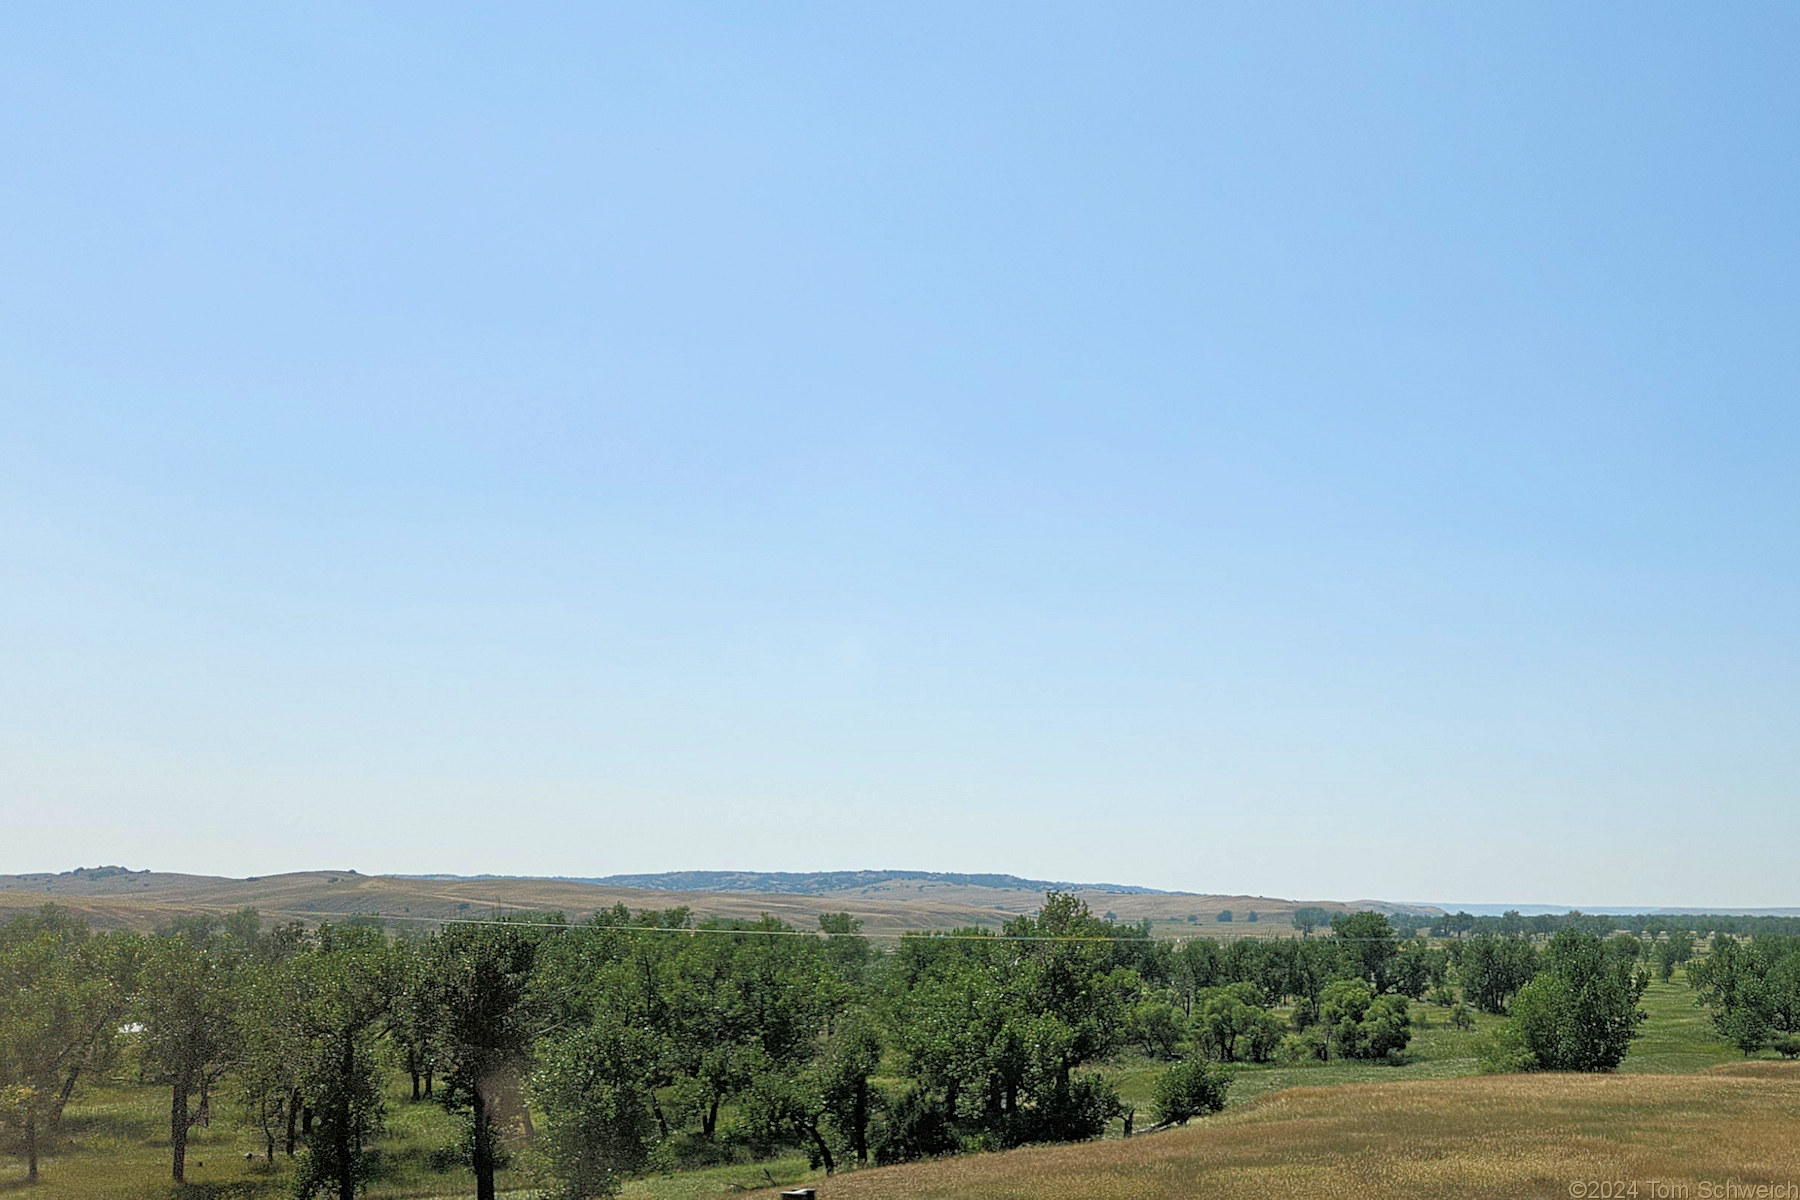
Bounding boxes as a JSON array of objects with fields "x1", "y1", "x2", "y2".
[{"x1": 133, "y1": 934, "x2": 241, "y2": 1184}]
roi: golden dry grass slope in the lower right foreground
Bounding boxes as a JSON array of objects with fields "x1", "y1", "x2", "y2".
[{"x1": 802, "y1": 1061, "x2": 1800, "y2": 1200}]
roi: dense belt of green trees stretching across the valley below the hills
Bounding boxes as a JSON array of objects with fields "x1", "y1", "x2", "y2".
[{"x1": 0, "y1": 892, "x2": 1742, "y2": 1200}]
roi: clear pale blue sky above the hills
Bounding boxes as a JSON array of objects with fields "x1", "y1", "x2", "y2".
[{"x1": 0, "y1": 2, "x2": 1800, "y2": 905}]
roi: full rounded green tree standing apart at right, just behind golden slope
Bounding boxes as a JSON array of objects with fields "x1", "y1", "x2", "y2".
[{"x1": 1507, "y1": 928, "x2": 1649, "y2": 1070}]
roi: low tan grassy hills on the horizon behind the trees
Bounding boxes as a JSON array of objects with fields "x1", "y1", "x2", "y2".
[{"x1": 0, "y1": 867, "x2": 1411, "y2": 937}]
